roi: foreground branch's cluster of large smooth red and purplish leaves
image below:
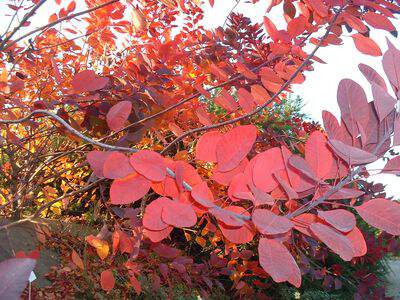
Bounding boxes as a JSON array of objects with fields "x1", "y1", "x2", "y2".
[{"x1": 83, "y1": 39, "x2": 400, "y2": 287}]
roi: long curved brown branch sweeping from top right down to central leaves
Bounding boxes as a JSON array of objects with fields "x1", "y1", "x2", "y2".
[{"x1": 161, "y1": 2, "x2": 347, "y2": 154}]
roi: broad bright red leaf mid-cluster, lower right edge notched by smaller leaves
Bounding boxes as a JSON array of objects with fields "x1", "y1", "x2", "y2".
[{"x1": 253, "y1": 147, "x2": 285, "y2": 193}]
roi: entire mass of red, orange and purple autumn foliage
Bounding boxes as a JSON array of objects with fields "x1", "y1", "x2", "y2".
[{"x1": 0, "y1": 0, "x2": 400, "y2": 298}]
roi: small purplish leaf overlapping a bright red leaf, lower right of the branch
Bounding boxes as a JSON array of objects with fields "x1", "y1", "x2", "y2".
[{"x1": 318, "y1": 209, "x2": 356, "y2": 232}]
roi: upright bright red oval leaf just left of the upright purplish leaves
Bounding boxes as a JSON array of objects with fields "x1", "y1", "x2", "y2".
[{"x1": 305, "y1": 131, "x2": 333, "y2": 179}]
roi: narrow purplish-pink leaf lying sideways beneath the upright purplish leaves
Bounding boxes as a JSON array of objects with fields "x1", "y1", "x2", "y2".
[{"x1": 329, "y1": 140, "x2": 378, "y2": 165}]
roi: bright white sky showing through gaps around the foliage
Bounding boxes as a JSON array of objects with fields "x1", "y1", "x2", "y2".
[{"x1": 0, "y1": 0, "x2": 400, "y2": 199}]
